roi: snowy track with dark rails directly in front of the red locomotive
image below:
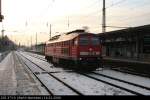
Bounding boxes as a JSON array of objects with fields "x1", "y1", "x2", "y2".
[{"x1": 78, "y1": 72, "x2": 150, "y2": 95}]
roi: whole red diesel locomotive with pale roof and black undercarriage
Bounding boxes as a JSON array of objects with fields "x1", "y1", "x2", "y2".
[{"x1": 45, "y1": 30, "x2": 102, "y2": 70}]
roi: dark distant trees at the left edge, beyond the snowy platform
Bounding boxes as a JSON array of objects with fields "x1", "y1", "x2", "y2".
[{"x1": 0, "y1": 36, "x2": 16, "y2": 52}]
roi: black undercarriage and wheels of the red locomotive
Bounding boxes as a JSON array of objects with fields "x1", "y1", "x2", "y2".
[{"x1": 45, "y1": 57, "x2": 102, "y2": 71}]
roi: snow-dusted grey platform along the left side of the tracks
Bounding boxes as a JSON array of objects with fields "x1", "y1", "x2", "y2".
[{"x1": 0, "y1": 52, "x2": 46, "y2": 95}]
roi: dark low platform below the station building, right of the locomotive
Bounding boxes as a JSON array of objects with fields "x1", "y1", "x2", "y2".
[{"x1": 103, "y1": 56, "x2": 150, "y2": 77}]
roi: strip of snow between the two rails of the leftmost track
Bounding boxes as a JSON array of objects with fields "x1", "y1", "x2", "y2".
[{"x1": 17, "y1": 54, "x2": 79, "y2": 95}]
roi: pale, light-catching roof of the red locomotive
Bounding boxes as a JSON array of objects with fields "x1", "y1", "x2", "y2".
[{"x1": 47, "y1": 31, "x2": 92, "y2": 44}]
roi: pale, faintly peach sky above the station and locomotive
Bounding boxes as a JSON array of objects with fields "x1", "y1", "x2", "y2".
[{"x1": 0, "y1": 0, "x2": 150, "y2": 45}]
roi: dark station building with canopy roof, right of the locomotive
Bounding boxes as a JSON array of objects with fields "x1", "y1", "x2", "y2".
[{"x1": 98, "y1": 25, "x2": 150, "y2": 61}]
